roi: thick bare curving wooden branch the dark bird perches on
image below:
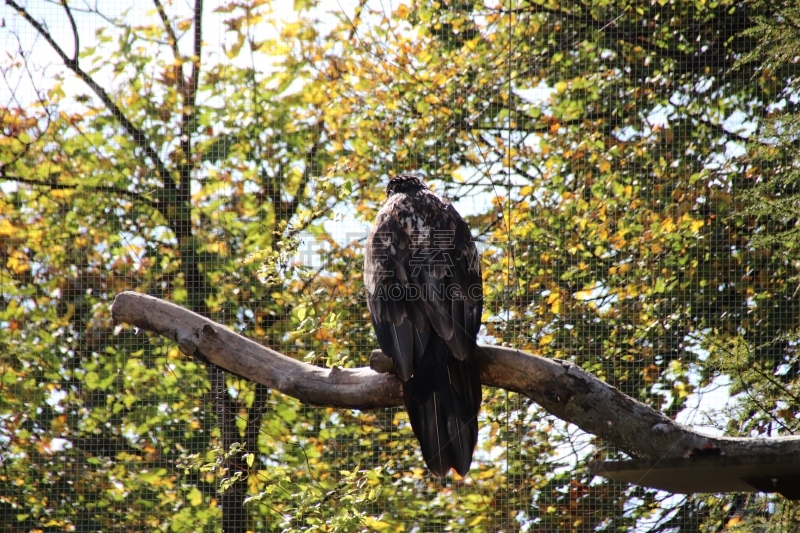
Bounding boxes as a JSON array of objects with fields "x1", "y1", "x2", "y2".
[{"x1": 112, "y1": 292, "x2": 800, "y2": 460}]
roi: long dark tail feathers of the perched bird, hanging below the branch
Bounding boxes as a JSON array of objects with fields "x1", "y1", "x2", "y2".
[{"x1": 403, "y1": 334, "x2": 481, "y2": 477}]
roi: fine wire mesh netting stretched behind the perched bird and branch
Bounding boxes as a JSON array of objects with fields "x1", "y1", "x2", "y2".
[{"x1": 0, "y1": 0, "x2": 800, "y2": 533}]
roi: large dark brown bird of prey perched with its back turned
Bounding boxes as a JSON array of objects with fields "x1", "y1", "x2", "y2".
[{"x1": 364, "y1": 174, "x2": 483, "y2": 477}]
